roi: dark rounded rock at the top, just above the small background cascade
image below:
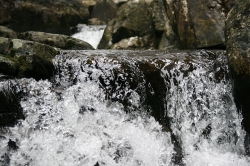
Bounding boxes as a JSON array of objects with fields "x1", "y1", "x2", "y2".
[{"x1": 91, "y1": 0, "x2": 118, "y2": 25}]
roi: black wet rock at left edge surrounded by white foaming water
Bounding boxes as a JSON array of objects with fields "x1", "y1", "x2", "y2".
[{"x1": 0, "y1": 82, "x2": 24, "y2": 127}]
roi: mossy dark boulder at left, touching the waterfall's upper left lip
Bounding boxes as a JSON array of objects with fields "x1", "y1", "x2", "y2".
[{"x1": 0, "y1": 37, "x2": 59, "y2": 80}]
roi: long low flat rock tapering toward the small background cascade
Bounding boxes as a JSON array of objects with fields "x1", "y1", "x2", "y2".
[{"x1": 18, "y1": 31, "x2": 94, "y2": 50}]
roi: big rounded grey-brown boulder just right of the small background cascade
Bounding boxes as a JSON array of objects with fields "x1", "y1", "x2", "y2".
[{"x1": 98, "y1": 1, "x2": 154, "y2": 49}]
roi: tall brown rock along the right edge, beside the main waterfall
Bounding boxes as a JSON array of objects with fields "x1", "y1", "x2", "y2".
[{"x1": 226, "y1": 0, "x2": 250, "y2": 133}]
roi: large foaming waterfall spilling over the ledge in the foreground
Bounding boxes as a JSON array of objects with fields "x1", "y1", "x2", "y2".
[{"x1": 0, "y1": 50, "x2": 250, "y2": 166}]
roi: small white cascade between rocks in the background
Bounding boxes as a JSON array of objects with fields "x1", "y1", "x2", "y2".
[{"x1": 72, "y1": 24, "x2": 106, "y2": 48}]
